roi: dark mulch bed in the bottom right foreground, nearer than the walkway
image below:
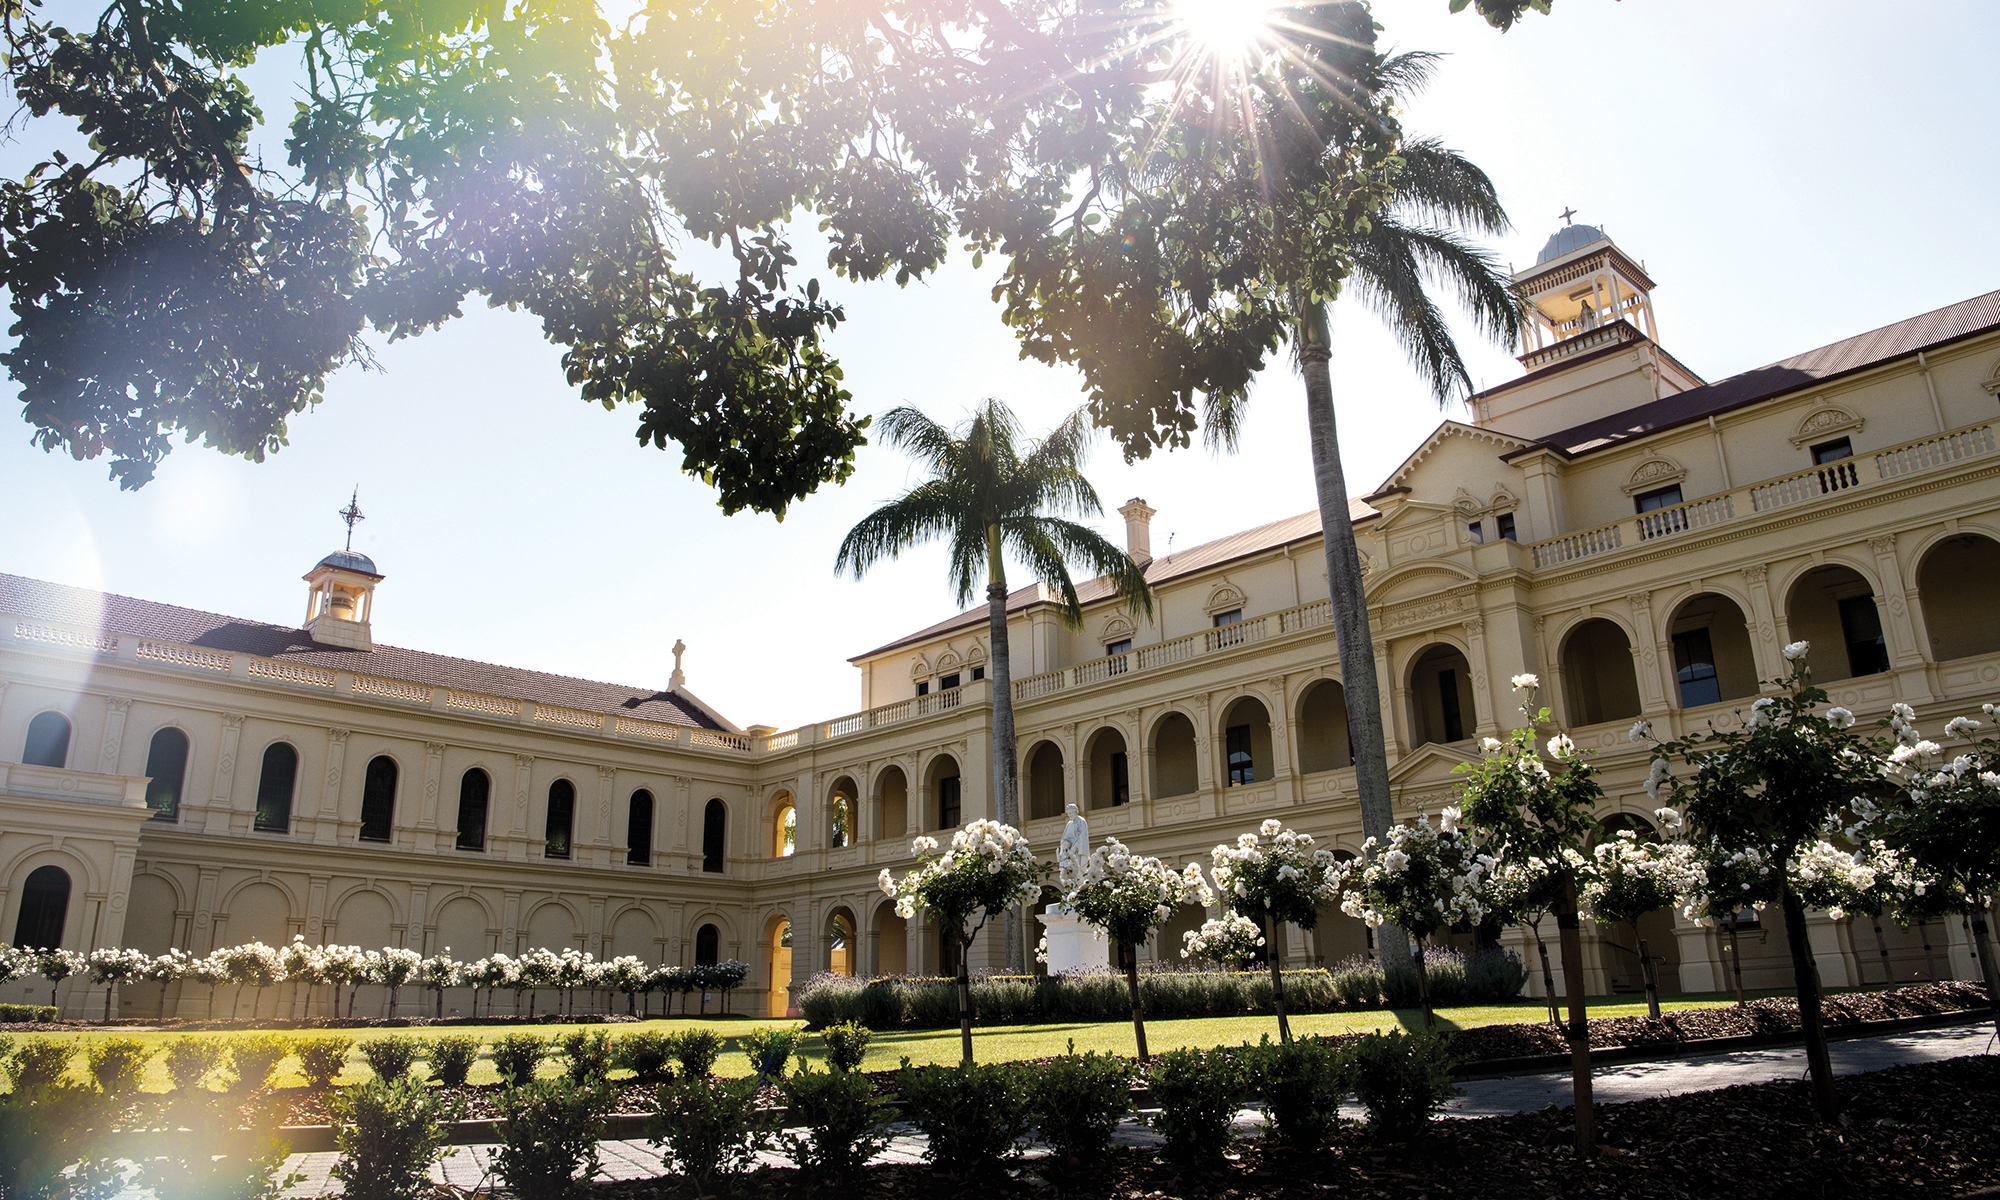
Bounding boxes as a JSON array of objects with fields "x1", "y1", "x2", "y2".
[{"x1": 590, "y1": 1056, "x2": 2000, "y2": 1200}]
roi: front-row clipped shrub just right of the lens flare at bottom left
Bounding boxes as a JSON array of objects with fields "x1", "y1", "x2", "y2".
[{"x1": 332, "y1": 1078, "x2": 456, "y2": 1200}]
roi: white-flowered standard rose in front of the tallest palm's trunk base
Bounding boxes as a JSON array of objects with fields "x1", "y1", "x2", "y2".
[{"x1": 1338, "y1": 808, "x2": 1494, "y2": 1030}]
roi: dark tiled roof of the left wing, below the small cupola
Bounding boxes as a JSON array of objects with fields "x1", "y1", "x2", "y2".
[{"x1": 0, "y1": 574, "x2": 726, "y2": 730}]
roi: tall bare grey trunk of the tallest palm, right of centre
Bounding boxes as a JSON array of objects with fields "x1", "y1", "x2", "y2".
[{"x1": 1298, "y1": 304, "x2": 1410, "y2": 970}]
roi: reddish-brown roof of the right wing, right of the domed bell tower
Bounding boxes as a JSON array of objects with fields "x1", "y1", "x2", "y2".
[{"x1": 1542, "y1": 292, "x2": 2000, "y2": 454}]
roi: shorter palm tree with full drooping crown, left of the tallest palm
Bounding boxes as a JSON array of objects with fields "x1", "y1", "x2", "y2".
[{"x1": 834, "y1": 400, "x2": 1152, "y2": 972}]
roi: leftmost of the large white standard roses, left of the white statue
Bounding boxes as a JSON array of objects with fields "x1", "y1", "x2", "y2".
[{"x1": 878, "y1": 820, "x2": 1046, "y2": 1062}]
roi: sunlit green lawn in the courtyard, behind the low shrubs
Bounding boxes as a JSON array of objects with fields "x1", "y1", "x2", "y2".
[{"x1": 0, "y1": 994, "x2": 1732, "y2": 1092}]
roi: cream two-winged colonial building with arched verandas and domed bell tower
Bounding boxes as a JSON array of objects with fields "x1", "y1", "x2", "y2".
[{"x1": 0, "y1": 226, "x2": 2000, "y2": 1014}]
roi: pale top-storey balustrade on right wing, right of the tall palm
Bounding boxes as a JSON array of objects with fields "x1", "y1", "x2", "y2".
[{"x1": 1528, "y1": 422, "x2": 1996, "y2": 568}]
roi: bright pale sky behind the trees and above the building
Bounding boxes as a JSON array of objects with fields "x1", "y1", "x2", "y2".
[{"x1": 0, "y1": 0, "x2": 2000, "y2": 728}]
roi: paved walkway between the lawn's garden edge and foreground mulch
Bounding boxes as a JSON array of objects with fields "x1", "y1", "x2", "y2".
[{"x1": 246, "y1": 1020, "x2": 1994, "y2": 1200}]
